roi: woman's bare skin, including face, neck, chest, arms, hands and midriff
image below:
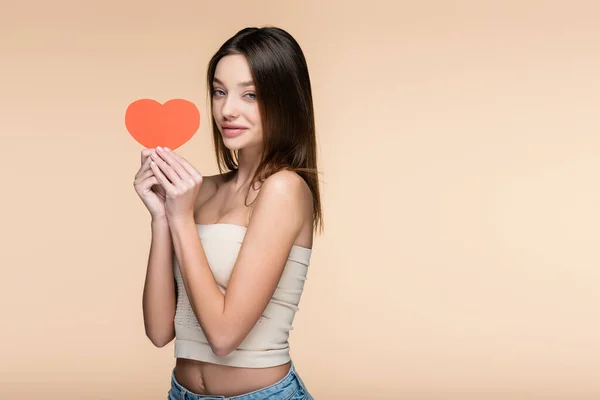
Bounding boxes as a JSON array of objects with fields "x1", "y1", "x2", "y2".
[{"x1": 134, "y1": 55, "x2": 313, "y2": 396}]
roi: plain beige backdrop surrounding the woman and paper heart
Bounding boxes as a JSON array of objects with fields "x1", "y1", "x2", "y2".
[{"x1": 0, "y1": 0, "x2": 600, "y2": 399}]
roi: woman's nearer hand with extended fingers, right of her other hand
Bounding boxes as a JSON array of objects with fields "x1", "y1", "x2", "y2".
[{"x1": 150, "y1": 147, "x2": 203, "y2": 221}]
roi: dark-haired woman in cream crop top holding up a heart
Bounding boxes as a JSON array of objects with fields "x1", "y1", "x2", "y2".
[{"x1": 135, "y1": 27, "x2": 322, "y2": 400}]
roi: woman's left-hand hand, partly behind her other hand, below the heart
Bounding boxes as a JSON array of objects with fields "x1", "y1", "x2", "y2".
[{"x1": 133, "y1": 149, "x2": 167, "y2": 220}]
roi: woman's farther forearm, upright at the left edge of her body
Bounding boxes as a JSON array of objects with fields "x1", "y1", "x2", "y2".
[{"x1": 142, "y1": 220, "x2": 176, "y2": 347}]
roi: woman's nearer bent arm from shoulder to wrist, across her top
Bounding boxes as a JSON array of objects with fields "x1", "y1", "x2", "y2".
[{"x1": 169, "y1": 171, "x2": 312, "y2": 357}]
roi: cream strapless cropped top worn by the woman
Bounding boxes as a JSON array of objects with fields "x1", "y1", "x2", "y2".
[{"x1": 173, "y1": 224, "x2": 312, "y2": 368}]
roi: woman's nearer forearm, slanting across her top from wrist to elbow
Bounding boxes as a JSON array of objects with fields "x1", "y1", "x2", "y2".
[{"x1": 169, "y1": 217, "x2": 230, "y2": 355}]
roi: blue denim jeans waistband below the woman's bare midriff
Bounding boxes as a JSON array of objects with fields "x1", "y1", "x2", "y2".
[{"x1": 168, "y1": 362, "x2": 314, "y2": 400}]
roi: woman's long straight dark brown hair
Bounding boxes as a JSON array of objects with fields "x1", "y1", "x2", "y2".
[{"x1": 207, "y1": 27, "x2": 323, "y2": 232}]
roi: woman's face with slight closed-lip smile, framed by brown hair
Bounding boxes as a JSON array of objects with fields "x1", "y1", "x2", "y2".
[{"x1": 212, "y1": 54, "x2": 262, "y2": 150}]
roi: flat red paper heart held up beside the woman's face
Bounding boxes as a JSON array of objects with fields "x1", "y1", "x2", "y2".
[{"x1": 125, "y1": 99, "x2": 200, "y2": 150}]
